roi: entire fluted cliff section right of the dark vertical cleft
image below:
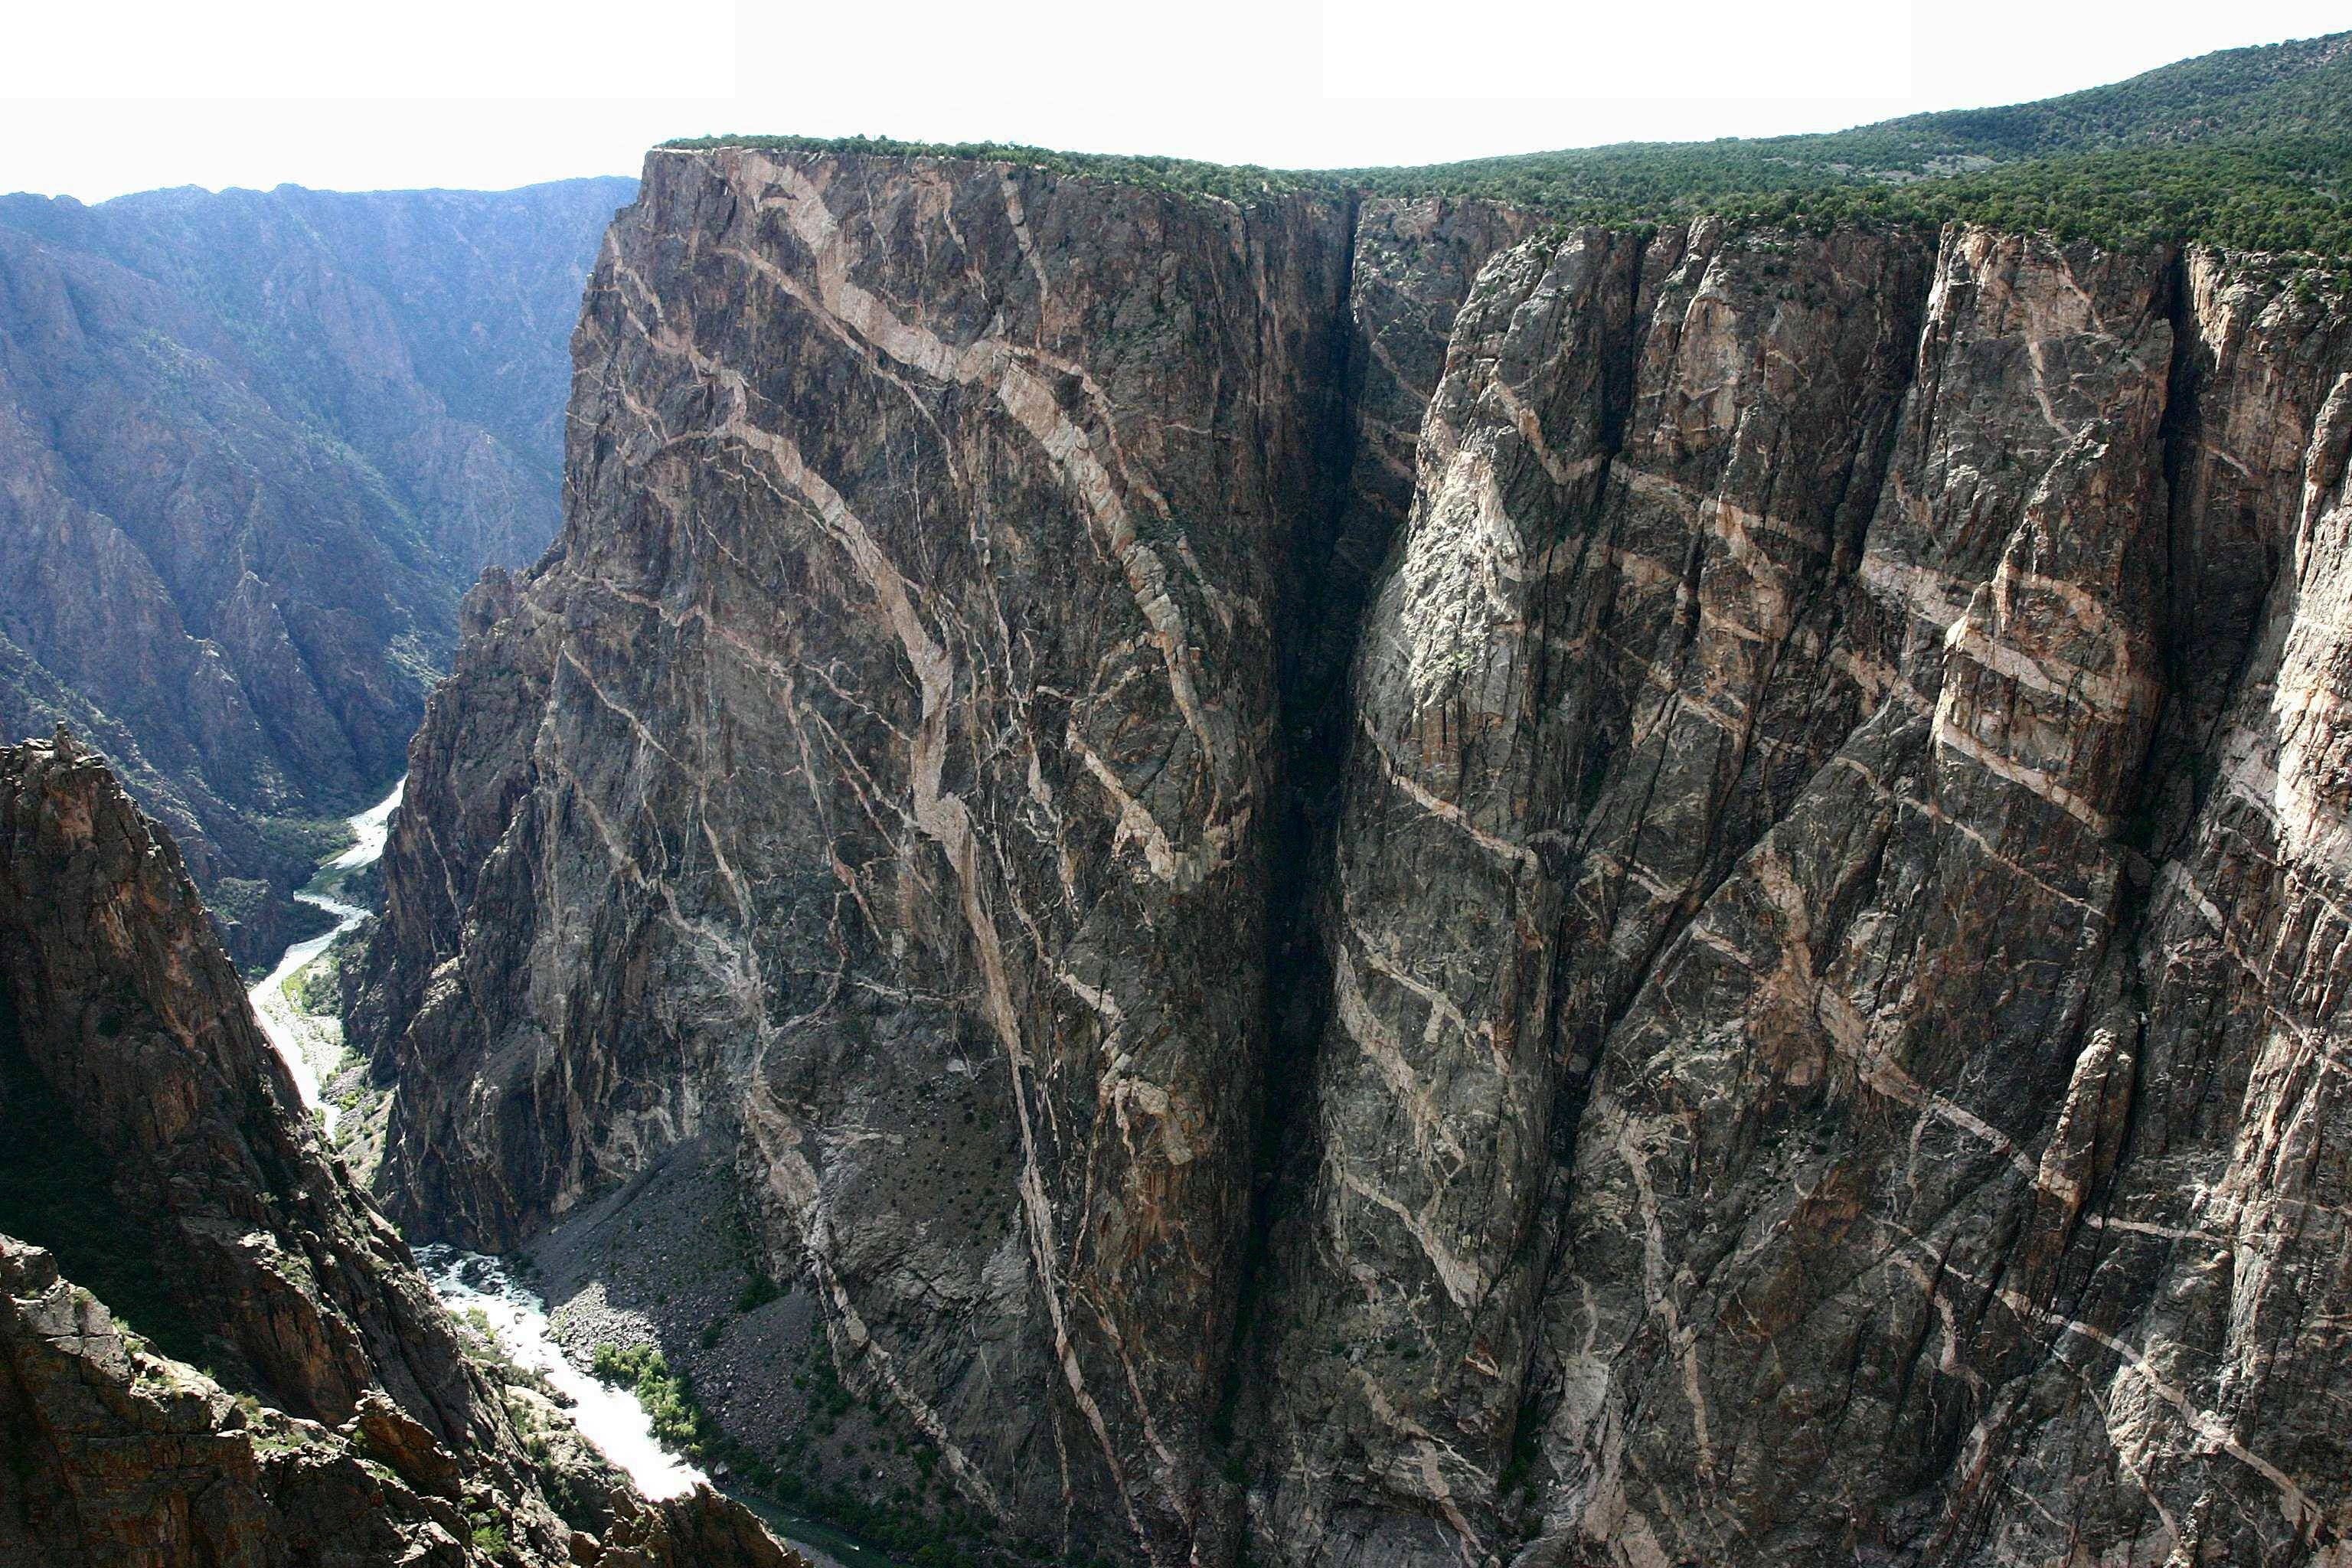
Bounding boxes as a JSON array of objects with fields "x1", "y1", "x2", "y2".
[{"x1": 1251, "y1": 228, "x2": 2352, "y2": 1566}]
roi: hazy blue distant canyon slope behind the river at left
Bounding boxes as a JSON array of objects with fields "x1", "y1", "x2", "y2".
[{"x1": 0, "y1": 178, "x2": 632, "y2": 964}]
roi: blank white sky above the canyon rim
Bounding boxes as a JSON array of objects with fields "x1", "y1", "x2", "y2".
[{"x1": 0, "y1": 0, "x2": 2352, "y2": 200}]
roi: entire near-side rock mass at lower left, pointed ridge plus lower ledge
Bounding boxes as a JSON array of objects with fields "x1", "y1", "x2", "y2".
[{"x1": 0, "y1": 733, "x2": 786, "y2": 1568}]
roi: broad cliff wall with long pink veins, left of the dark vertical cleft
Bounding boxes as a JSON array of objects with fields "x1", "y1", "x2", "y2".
[{"x1": 360, "y1": 141, "x2": 1348, "y2": 1540}]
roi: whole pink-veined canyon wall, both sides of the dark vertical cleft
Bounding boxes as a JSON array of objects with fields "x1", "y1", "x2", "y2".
[{"x1": 358, "y1": 151, "x2": 2352, "y2": 1568}]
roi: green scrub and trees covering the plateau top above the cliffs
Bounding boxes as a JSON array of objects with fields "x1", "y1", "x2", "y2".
[{"x1": 665, "y1": 38, "x2": 2352, "y2": 256}]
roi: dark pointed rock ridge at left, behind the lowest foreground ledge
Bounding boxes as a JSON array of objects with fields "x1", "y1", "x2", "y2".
[{"x1": 0, "y1": 743, "x2": 501, "y2": 1441}]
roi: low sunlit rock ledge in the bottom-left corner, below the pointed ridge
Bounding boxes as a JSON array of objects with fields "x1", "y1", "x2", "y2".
[{"x1": 0, "y1": 1236, "x2": 807, "y2": 1568}]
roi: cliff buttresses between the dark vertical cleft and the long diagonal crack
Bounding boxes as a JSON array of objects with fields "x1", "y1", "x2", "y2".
[{"x1": 1268, "y1": 214, "x2": 1924, "y2": 1554}]
